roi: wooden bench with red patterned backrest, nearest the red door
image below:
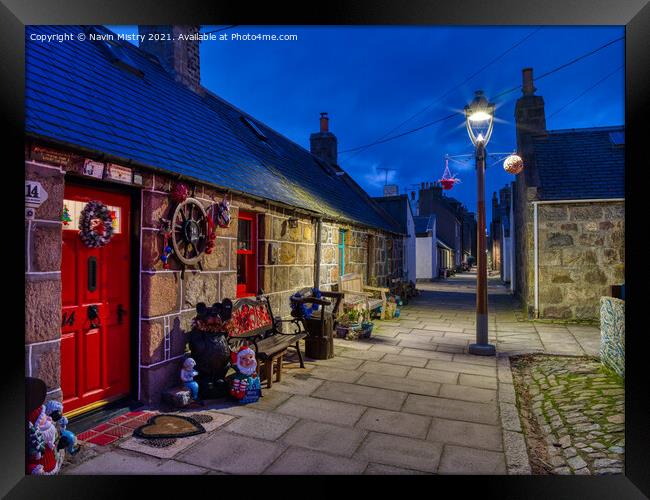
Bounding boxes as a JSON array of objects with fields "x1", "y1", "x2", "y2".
[{"x1": 225, "y1": 295, "x2": 307, "y2": 388}]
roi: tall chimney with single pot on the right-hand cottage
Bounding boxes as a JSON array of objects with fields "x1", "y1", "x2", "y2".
[{"x1": 515, "y1": 68, "x2": 546, "y2": 186}]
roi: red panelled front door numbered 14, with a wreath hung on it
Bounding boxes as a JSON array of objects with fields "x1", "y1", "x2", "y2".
[{"x1": 61, "y1": 185, "x2": 131, "y2": 413}]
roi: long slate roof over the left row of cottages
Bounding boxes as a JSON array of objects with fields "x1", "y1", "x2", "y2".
[{"x1": 25, "y1": 26, "x2": 400, "y2": 233}]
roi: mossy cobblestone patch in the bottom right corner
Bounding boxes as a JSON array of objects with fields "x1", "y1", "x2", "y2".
[{"x1": 511, "y1": 355, "x2": 625, "y2": 475}]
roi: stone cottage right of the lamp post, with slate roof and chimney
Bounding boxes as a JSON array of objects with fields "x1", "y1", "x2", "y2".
[{"x1": 513, "y1": 68, "x2": 625, "y2": 319}]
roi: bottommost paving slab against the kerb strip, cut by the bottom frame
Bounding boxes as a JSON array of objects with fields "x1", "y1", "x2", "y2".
[{"x1": 438, "y1": 445, "x2": 506, "y2": 475}]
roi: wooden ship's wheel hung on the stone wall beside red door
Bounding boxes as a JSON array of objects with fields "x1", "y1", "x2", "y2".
[{"x1": 171, "y1": 197, "x2": 208, "y2": 269}]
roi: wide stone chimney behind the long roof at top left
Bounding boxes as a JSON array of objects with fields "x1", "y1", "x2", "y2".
[{"x1": 138, "y1": 25, "x2": 202, "y2": 93}]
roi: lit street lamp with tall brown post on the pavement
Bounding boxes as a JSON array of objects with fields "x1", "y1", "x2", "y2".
[{"x1": 465, "y1": 90, "x2": 496, "y2": 356}]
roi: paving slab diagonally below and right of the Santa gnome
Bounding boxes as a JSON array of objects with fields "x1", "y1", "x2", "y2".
[{"x1": 276, "y1": 396, "x2": 366, "y2": 426}]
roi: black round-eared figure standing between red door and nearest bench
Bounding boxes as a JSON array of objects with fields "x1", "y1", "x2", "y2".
[{"x1": 188, "y1": 299, "x2": 232, "y2": 399}]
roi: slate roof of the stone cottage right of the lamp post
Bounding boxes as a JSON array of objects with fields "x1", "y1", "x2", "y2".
[{"x1": 533, "y1": 126, "x2": 625, "y2": 200}]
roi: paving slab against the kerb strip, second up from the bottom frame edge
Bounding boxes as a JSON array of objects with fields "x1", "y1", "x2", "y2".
[{"x1": 427, "y1": 417, "x2": 503, "y2": 451}]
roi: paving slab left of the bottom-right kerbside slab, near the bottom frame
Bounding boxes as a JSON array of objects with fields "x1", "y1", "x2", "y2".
[{"x1": 355, "y1": 433, "x2": 442, "y2": 472}]
